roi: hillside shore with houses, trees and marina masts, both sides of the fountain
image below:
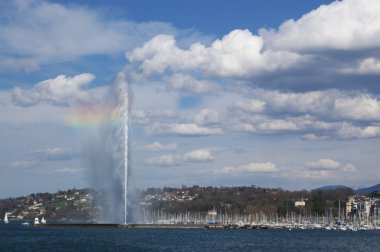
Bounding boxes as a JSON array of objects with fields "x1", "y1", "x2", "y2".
[{"x1": 0, "y1": 186, "x2": 380, "y2": 229}]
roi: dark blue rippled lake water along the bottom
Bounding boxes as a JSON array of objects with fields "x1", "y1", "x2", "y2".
[{"x1": 0, "y1": 222, "x2": 380, "y2": 252}]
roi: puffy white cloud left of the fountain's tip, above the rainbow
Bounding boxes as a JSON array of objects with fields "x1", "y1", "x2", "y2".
[{"x1": 13, "y1": 73, "x2": 95, "y2": 107}]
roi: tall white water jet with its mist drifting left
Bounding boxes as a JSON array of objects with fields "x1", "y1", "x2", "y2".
[{"x1": 86, "y1": 72, "x2": 131, "y2": 224}]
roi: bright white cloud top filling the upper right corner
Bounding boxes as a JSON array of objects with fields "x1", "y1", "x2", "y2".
[{"x1": 259, "y1": 0, "x2": 380, "y2": 52}]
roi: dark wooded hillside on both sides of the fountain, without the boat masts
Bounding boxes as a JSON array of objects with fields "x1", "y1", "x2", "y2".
[{"x1": 0, "y1": 186, "x2": 379, "y2": 220}]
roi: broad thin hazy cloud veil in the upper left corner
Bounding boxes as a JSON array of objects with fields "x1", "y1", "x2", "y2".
[{"x1": 0, "y1": 0, "x2": 175, "y2": 71}]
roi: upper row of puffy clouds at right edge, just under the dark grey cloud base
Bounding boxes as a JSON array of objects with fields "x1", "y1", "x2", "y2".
[{"x1": 243, "y1": 89, "x2": 380, "y2": 120}]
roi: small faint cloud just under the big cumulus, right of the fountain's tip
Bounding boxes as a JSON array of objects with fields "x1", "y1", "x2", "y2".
[{"x1": 164, "y1": 74, "x2": 217, "y2": 94}]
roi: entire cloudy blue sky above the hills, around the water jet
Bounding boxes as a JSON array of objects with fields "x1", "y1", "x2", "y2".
[{"x1": 0, "y1": 0, "x2": 380, "y2": 197}]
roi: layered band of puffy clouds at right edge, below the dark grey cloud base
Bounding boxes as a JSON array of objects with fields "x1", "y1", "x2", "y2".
[{"x1": 224, "y1": 88, "x2": 380, "y2": 140}]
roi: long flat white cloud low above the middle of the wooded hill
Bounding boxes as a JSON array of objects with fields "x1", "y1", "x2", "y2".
[{"x1": 212, "y1": 162, "x2": 278, "y2": 174}]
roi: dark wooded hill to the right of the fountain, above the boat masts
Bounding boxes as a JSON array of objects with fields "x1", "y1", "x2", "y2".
[{"x1": 144, "y1": 186, "x2": 354, "y2": 215}]
